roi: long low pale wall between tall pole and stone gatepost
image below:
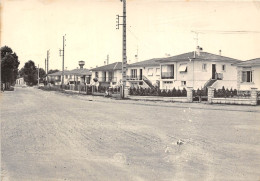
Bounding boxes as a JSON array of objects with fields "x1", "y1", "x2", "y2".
[{"x1": 128, "y1": 96, "x2": 188, "y2": 102}]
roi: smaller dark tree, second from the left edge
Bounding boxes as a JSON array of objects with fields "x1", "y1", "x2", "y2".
[{"x1": 19, "y1": 60, "x2": 38, "y2": 86}]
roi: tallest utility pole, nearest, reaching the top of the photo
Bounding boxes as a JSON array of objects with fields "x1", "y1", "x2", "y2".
[{"x1": 117, "y1": 0, "x2": 127, "y2": 98}]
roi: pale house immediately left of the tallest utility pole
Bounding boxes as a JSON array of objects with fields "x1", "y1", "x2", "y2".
[{"x1": 91, "y1": 62, "x2": 122, "y2": 87}]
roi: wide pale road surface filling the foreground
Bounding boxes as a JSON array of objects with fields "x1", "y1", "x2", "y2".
[{"x1": 0, "y1": 88, "x2": 260, "y2": 181}]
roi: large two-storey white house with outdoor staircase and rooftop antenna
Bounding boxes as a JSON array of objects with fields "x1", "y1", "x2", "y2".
[{"x1": 159, "y1": 47, "x2": 241, "y2": 89}]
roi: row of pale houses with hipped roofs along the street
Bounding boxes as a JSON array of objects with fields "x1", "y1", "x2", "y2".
[{"x1": 49, "y1": 47, "x2": 260, "y2": 90}]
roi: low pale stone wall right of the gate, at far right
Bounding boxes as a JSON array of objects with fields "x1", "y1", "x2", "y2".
[{"x1": 211, "y1": 98, "x2": 252, "y2": 105}]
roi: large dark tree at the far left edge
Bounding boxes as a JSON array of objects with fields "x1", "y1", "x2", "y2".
[{"x1": 0, "y1": 46, "x2": 20, "y2": 88}]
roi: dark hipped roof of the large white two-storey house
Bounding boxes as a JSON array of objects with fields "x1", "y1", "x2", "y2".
[{"x1": 156, "y1": 51, "x2": 241, "y2": 63}]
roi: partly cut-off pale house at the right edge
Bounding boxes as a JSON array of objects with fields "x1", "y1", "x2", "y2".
[{"x1": 236, "y1": 58, "x2": 260, "y2": 90}]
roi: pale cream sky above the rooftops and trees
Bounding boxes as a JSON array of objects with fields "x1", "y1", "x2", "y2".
[{"x1": 0, "y1": 0, "x2": 260, "y2": 70}]
